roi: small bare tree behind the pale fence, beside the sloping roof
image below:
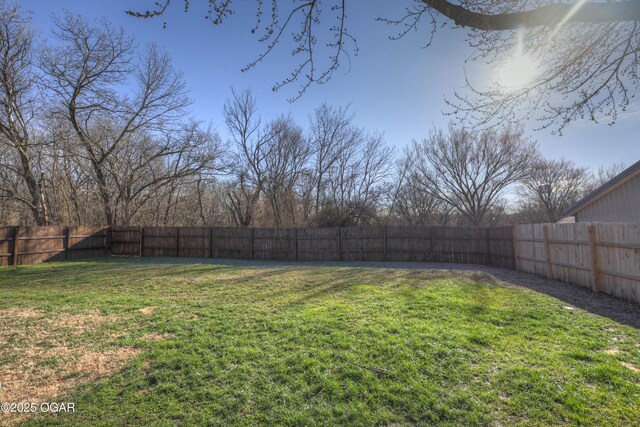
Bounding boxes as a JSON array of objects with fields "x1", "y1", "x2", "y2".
[{"x1": 520, "y1": 159, "x2": 589, "y2": 222}]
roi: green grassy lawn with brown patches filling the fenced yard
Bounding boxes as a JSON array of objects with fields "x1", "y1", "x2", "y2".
[{"x1": 0, "y1": 258, "x2": 640, "y2": 426}]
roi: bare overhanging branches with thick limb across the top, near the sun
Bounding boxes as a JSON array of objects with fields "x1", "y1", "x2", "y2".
[{"x1": 127, "y1": 0, "x2": 640, "y2": 133}]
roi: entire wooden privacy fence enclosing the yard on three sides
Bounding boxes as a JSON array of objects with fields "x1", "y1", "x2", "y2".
[{"x1": 0, "y1": 223, "x2": 640, "y2": 302}]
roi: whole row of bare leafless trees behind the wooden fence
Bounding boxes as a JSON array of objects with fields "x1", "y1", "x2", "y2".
[{"x1": 0, "y1": 6, "x2": 620, "y2": 227}]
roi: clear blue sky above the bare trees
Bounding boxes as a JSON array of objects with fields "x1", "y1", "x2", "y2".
[{"x1": 21, "y1": 0, "x2": 640, "y2": 171}]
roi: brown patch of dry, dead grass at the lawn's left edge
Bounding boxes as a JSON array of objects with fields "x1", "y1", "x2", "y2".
[{"x1": 0, "y1": 308, "x2": 140, "y2": 425}]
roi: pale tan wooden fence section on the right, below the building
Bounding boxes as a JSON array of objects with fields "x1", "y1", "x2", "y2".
[{"x1": 514, "y1": 222, "x2": 640, "y2": 302}]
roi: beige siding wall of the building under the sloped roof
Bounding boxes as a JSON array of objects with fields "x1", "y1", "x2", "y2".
[{"x1": 576, "y1": 174, "x2": 640, "y2": 222}]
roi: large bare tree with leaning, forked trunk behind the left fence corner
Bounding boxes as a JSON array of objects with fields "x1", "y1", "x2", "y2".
[{"x1": 41, "y1": 12, "x2": 189, "y2": 225}]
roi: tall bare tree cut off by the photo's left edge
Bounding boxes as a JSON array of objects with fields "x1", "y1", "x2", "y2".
[{"x1": 0, "y1": 2, "x2": 49, "y2": 225}]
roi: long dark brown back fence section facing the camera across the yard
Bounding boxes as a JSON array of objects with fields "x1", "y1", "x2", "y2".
[{"x1": 111, "y1": 227, "x2": 514, "y2": 268}]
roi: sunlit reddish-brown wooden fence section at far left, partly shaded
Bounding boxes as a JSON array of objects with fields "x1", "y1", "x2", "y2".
[{"x1": 0, "y1": 227, "x2": 109, "y2": 265}]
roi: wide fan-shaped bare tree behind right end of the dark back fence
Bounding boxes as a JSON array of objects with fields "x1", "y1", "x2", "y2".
[{"x1": 413, "y1": 125, "x2": 538, "y2": 226}]
